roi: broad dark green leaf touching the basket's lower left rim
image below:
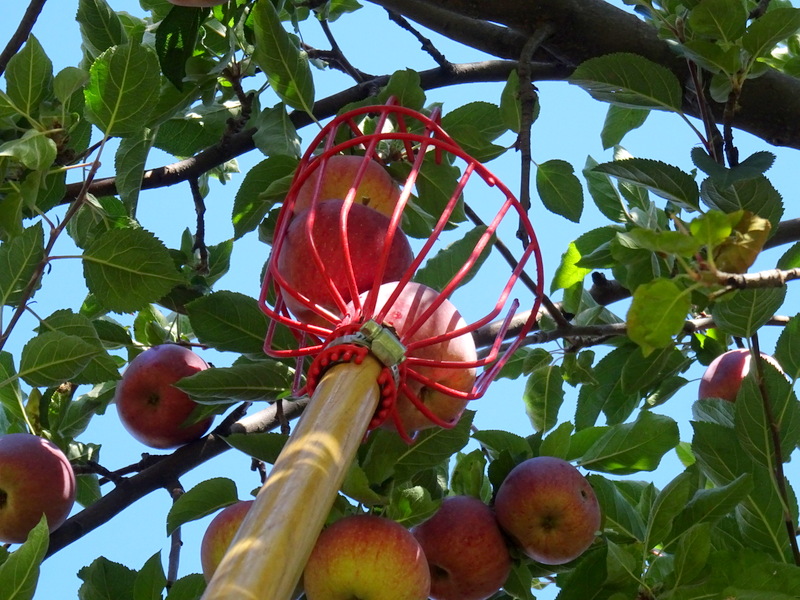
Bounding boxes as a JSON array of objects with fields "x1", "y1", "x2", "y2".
[{"x1": 186, "y1": 290, "x2": 267, "y2": 355}]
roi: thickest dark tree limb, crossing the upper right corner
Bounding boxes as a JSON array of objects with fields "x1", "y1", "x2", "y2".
[{"x1": 370, "y1": 0, "x2": 800, "y2": 149}]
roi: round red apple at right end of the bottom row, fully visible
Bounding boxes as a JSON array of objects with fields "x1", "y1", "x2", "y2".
[{"x1": 494, "y1": 456, "x2": 600, "y2": 565}]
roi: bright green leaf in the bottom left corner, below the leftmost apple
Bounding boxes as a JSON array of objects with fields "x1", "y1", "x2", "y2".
[{"x1": 0, "y1": 516, "x2": 50, "y2": 600}]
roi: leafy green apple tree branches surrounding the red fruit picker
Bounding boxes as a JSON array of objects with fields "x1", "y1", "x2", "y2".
[{"x1": 0, "y1": 0, "x2": 800, "y2": 600}]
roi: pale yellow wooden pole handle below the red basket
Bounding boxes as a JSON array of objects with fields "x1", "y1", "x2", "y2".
[{"x1": 202, "y1": 354, "x2": 382, "y2": 600}]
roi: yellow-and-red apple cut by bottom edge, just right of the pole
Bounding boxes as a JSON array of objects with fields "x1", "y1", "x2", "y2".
[{"x1": 303, "y1": 515, "x2": 431, "y2": 600}]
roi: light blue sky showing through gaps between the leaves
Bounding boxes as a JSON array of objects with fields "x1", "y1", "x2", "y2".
[{"x1": 0, "y1": 0, "x2": 798, "y2": 599}]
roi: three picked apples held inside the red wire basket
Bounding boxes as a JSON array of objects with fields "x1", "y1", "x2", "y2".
[{"x1": 275, "y1": 155, "x2": 478, "y2": 436}]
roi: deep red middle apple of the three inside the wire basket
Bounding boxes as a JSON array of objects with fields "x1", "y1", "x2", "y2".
[{"x1": 276, "y1": 200, "x2": 414, "y2": 323}]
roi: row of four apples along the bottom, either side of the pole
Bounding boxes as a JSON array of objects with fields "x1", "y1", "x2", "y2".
[{"x1": 200, "y1": 456, "x2": 601, "y2": 600}]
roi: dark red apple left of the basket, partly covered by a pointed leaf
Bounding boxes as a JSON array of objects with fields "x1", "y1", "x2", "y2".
[{"x1": 114, "y1": 344, "x2": 214, "y2": 448}]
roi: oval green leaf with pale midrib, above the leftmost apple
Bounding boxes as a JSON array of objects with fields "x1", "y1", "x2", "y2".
[{"x1": 19, "y1": 331, "x2": 98, "y2": 387}]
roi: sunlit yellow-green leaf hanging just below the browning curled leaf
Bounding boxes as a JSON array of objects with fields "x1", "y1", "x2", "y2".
[{"x1": 627, "y1": 279, "x2": 691, "y2": 356}]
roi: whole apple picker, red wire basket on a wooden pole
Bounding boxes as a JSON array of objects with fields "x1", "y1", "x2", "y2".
[{"x1": 203, "y1": 99, "x2": 543, "y2": 600}]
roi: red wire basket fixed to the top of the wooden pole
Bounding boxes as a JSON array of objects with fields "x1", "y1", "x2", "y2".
[{"x1": 259, "y1": 100, "x2": 543, "y2": 441}]
